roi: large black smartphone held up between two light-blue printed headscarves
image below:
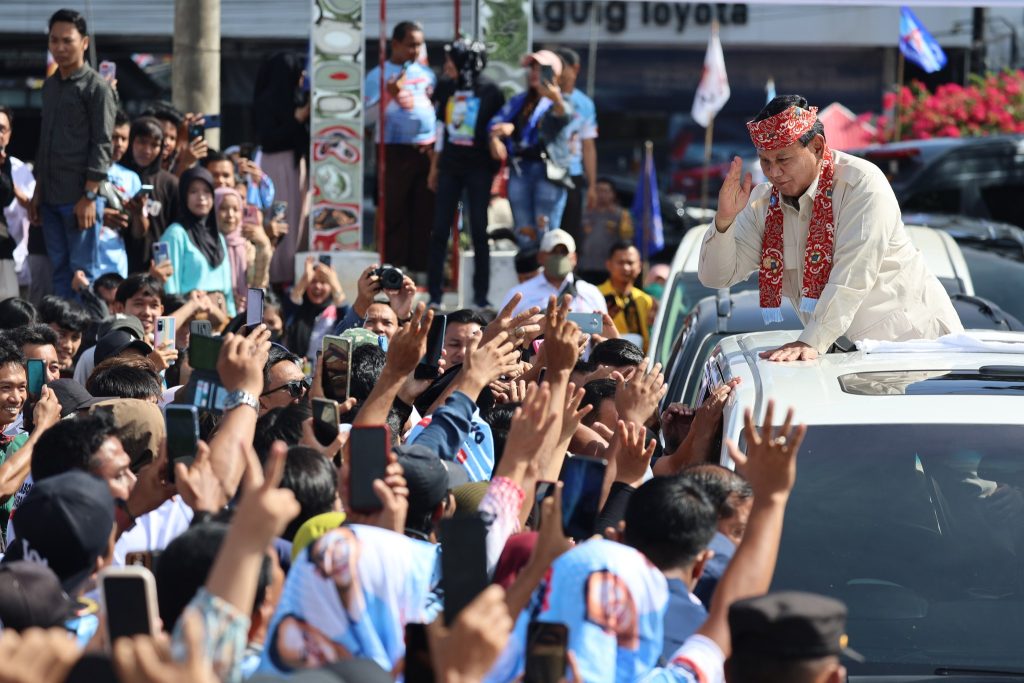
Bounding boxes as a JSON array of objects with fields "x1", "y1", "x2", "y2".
[{"x1": 440, "y1": 515, "x2": 490, "y2": 626}]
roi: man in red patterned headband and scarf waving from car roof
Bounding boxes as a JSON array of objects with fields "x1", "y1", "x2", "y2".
[{"x1": 697, "y1": 95, "x2": 964, "y2": 360}]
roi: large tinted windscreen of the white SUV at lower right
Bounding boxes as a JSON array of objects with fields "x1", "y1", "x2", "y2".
[{"x1": 772, "y1": 423, "x2": 1024, "y2": 677}]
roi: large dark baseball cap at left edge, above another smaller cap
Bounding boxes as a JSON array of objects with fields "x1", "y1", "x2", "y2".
[{"x1": 4, "y1": 470, "x2": 114, "y2": 594}]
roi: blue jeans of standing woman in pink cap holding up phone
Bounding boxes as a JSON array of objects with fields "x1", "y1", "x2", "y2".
[{"x1": 509, "y1": 160, "x2": 568, "y2": 249}]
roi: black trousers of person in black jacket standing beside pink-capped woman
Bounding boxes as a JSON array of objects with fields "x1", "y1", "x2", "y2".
[{"x1": 427, "y1": 169, "x2": 494, "y2": 306}]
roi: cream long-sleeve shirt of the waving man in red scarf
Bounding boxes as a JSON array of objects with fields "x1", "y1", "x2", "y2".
[{"x1": 697, "y1": 152, "x2": 964, "y2": 352}]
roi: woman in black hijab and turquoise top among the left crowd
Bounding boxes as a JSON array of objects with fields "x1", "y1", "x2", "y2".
[{"x1": 160, "y1": 166, "x2": 236, "y2": 316}]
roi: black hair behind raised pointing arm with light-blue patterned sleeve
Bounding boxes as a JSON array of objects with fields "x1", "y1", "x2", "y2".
[{"x1": 156, "y1": 521, "x2": 272, "y2": 631}]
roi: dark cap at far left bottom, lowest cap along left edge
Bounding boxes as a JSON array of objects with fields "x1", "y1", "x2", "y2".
[{"x1": 0, "y1": 560, "x2": 76, "y2": 631}]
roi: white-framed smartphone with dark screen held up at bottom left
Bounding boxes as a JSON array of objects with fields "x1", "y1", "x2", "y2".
[{"x1": 99, "y1": 566, "x2": 160, "y2": 645}]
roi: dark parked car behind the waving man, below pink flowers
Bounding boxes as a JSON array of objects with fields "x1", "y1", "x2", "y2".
[{"x1": 851, "y1": 135, "x2": 1024, "y2": 227}]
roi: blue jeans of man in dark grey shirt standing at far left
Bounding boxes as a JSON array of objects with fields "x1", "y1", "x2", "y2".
[{"x1": 40, "y1": 199, "x2": 105, "y2": 299}]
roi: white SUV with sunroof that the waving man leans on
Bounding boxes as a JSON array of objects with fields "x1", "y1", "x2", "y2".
[{"x1": 705, "y1": 331, "x2": 1024, "y2": 680}]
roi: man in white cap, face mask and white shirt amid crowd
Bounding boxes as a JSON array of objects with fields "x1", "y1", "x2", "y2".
[{"x1": 502, "y1": 229, "x2": 608, "y2": 314}]
